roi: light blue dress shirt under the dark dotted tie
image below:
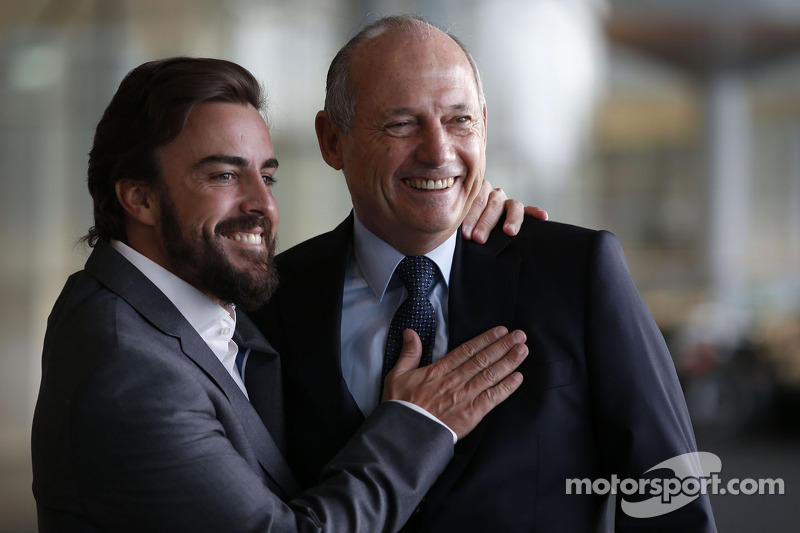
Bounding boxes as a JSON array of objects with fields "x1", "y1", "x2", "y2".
[{"x1": 341, "y1": 212, "x2": 456, "y2": 416}]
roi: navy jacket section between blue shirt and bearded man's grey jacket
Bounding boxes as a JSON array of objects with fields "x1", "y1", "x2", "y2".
[{"x1": 268, "y1": 216, "x2": 364, "y2": 486}]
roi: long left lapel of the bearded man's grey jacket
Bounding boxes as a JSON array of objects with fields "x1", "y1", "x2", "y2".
[{"x1": 86, "y1": 241, "x2": 298, "y2": 494}]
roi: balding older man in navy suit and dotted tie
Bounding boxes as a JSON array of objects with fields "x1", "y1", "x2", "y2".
[{"x1": 254, "y1": 16, "x2": 715, "y2": 532}]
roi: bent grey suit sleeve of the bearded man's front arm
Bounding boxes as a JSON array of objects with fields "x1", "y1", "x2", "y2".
[{"x1": 37, "y1": 298, "x2": 453, "y2": 532}]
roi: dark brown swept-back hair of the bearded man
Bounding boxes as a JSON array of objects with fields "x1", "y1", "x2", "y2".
[{"x1": 81, "y1": 57, "x2": 265, "y2": 246}]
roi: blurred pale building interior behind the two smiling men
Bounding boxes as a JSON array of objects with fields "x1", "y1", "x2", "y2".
[{"x1": 0, "y1": 0, "x2": 800, "y2": 532}]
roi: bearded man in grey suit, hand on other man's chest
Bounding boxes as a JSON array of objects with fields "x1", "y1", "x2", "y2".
[{"x1": 32, "y1": 58, "x2": 527, "y2": 532}]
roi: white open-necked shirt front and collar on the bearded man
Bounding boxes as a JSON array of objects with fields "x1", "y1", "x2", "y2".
[{"x1": 111, "y1": 240, "x2": 249, "y2": 399}]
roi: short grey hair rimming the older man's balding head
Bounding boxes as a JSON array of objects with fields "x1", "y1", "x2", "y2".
[{"x1": 325, "y1": 15, "x2": 486, "y2": 133}]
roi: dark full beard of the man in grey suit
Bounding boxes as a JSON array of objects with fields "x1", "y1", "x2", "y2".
[{"x1": 159, "y1": 194, "x2": 278, "y2": 311}]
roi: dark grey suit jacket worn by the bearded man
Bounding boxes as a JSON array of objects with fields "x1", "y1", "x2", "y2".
[{"x1": 32, "y1": 242, "x2": 453, "y2": 532}]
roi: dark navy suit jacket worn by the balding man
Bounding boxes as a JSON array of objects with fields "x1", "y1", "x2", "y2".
[{"x1": 253, "y1": 215, "x2": 714, "y2": 532}]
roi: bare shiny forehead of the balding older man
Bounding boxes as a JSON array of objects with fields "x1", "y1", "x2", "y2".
[{"x1": 351, "y1": 28, "x2": 478, "y2": 105}]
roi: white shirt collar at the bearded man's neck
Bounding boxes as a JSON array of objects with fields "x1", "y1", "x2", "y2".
[{"x1": 111, "y1": 240, "x2": 236, "y2": 340}]
